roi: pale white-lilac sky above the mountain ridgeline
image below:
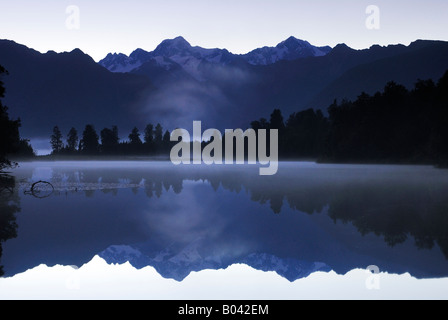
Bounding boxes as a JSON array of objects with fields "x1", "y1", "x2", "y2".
[{"x1": 0, "y1": 0, "x2": 448, "y2": 61}]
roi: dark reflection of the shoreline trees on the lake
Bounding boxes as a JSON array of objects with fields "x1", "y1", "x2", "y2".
[{"x1": 15, "y1": 166, "x2": 448, "y2": 258}]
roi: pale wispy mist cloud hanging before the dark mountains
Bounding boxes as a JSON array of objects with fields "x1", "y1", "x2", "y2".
[{"x1": 136, "y1": 65, "x2": 251, "y2": 131}]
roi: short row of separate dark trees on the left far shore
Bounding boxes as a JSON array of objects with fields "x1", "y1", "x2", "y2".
[{"x1": 50, "y1": 123, "x2": 171, "y2": 156}]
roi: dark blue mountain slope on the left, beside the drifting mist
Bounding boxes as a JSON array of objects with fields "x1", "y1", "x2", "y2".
[{"x1": 0, "y1": 40, "x2": 153, "y2": 138}]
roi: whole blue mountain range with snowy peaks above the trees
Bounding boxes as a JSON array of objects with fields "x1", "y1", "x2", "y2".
[{"x1": 0, "y1": 37, "x2": 448, "y2": 150}]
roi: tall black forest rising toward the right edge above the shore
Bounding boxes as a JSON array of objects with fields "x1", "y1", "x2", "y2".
[{"x1": 251, "y1": 71, "x2": 448, "y2": 167}]
